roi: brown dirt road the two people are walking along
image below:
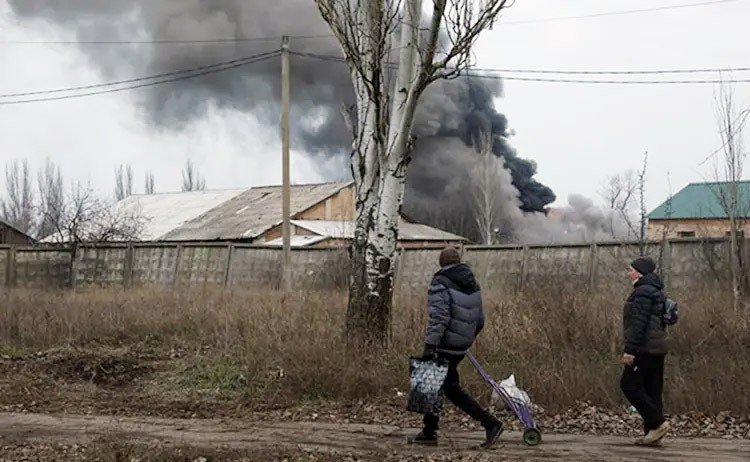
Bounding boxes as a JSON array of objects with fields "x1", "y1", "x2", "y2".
[{"x1": 0, "y1": 413, "x2": 750, "y2": 462}]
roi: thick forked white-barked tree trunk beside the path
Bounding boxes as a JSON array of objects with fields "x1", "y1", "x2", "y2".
[{"x1": 347, "y1": 0, "x2": 421, "y2": 348}]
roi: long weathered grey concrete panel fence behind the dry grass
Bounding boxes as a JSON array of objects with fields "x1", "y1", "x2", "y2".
[{"x1": 0, "y1": 240, "x2": 750, "y2": 295}]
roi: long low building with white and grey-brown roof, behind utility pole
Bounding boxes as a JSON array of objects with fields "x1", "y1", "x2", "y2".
[{"x1": 117, "y1": 182, "x2": 465, "y2": 248}]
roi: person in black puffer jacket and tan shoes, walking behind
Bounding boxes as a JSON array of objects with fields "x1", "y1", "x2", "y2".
[{"x1": 620, "y1": 257, "x2": 670, "y2": 445}]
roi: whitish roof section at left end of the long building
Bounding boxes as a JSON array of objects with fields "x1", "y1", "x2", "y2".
[{"x1": 116, "y1": 189, "x2": 245, "y2": 241}]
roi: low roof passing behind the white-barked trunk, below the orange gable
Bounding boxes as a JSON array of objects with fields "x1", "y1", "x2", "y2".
[{"x1": 292, "y1": 219, "x2": 465, "y2": 242}]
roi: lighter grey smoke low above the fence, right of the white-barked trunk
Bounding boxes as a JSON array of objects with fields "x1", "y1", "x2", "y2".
[{"x1": 406, "y1": 136, "x2": 635, "y2": 244}]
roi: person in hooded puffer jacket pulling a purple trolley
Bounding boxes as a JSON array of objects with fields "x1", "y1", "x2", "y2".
[{"x1": 410, "y1": 247, "x2": 503, "y2": 448}]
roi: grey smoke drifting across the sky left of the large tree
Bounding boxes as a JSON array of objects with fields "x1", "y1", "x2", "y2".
[{"x1": 9, "y1": 0, "x2": 351, "y2": 155}]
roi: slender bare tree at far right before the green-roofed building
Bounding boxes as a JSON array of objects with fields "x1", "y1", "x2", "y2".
[{"x1": 713, "y1": 84, "x2": 750, "y2": 320}]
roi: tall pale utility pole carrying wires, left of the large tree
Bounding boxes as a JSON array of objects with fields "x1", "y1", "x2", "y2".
[{"x1": 281, "y1": 35, "x2": 292, "y2": 292}]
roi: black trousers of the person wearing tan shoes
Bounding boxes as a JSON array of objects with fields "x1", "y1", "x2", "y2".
[{"x1": 620, "y1": 354, "x2": 664, "y2": 434}]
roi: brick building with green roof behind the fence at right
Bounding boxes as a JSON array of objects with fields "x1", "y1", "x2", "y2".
[{"x1": 648, "y1": 181, "x2": 750, "y2": 240}]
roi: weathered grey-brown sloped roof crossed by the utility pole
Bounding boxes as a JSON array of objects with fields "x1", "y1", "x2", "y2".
[{"x1": 161, "y1": 182, "x2": 352, "y2": 241}]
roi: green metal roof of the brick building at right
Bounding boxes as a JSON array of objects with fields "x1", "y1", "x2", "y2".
[{"x1": 648, "y1": 181, "x2": 750, "y2": 220}]
